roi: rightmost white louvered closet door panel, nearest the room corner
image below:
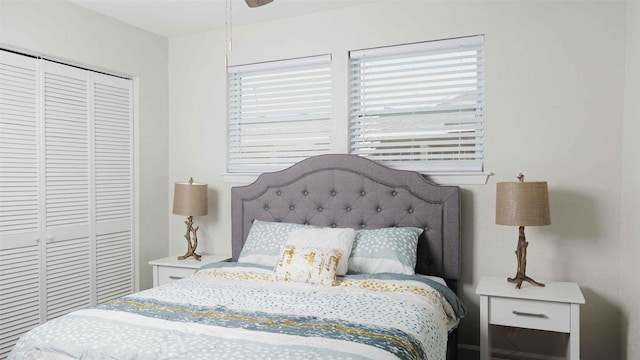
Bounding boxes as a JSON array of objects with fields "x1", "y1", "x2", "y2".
[{"x1": 93, "y1": 74, "x2": 134, "y2": 303}]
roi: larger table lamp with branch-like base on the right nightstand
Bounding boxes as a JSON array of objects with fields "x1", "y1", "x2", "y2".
[{"x1": 496, "y1": 174, "x2": 551, "y2": 289}]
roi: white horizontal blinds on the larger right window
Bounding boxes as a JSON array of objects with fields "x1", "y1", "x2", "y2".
[{"x1": 349, "y1": 36, "x2": 484, "y2": 173}]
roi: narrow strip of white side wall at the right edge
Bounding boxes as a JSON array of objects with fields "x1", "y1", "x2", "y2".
[{"x1": 620, "y1": 2, "x2": 640, "y2": 359}]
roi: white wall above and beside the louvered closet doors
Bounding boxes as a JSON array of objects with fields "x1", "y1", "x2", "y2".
[{"x1": 0, "y1": 0, "x2": 169, "y2": 289}]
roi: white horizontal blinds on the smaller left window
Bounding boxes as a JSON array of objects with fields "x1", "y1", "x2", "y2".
[{"x1": 227, "y1": 55, "x2": 333, "y2": 173}]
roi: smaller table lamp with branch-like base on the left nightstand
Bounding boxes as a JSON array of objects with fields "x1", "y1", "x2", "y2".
[{"x1": 173, "y1": 178, "x2": 208, "y2": 261}]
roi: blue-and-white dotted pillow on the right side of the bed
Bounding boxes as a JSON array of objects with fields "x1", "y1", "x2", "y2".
[{"x1": 349, "y1": 227, "x2": 422, "y2": 275}]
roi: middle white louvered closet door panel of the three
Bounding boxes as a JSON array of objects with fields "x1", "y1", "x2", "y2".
[{"x1": 44, "y1": 61, "x2": 92, "y2": 320}]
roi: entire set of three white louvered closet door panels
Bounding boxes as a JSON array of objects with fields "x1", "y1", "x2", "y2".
[{"x1": 0, "y1": 50, "x2": 135, "y2": 359}]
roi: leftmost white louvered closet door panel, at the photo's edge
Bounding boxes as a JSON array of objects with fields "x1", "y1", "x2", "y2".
[{"x1": 0, "y1": 51, "x2": 40, "y2": 359}]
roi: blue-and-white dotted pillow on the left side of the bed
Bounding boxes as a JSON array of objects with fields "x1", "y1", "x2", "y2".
[{"x1": 238, "y1": 220, "x2": 316, "y2": 266}]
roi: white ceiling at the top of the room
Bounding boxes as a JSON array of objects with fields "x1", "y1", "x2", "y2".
[{"x1": 67, "y1": 0, "x2": 373, "y2": 37}]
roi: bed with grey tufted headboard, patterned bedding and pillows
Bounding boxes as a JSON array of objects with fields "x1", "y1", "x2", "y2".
[{"x1": 9, "y1": 155, "x2": 466, "y2": 360}]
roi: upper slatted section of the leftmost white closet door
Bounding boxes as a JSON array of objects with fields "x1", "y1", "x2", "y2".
[{"x1": 0, "y1": 52, "x2": 39, "y2": 251}]
